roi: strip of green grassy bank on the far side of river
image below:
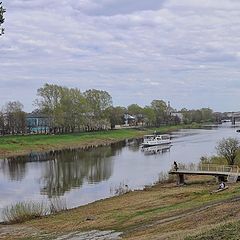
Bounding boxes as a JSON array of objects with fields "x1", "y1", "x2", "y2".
[{"x1": 0, "y1": 125, "x2": 200, "y2": 157}]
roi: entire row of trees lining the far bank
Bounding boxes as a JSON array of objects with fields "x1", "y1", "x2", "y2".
[{"x1": 0, "y1": 84, "x2": 220, "y2": 135}]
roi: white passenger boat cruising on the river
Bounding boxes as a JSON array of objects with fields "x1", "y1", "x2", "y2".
[{"x1": 142, "y1": 134, "x2": 171, "y2": 147}]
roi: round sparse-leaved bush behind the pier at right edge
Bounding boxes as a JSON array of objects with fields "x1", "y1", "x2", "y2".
[{"x1": 216, "y1": 137, "x2": 240, "y2": 165}]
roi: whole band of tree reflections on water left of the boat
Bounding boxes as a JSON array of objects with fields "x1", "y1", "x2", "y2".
[{"x1": 0, "y1": 141, "x2": 127, "y2": 198}]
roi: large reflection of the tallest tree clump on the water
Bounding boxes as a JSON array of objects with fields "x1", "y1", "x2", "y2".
[{"x1": 41, "y1": 147, "x2": 116, "y2": 197}]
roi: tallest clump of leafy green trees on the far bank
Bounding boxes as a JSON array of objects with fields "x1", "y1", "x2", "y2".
[{"x1": 35, "y1": 84, "x2": 112, "y2": 133}]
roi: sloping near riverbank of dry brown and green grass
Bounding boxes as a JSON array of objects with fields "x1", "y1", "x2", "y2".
[{"x1": 0, "y1": 174, "x2": 240, "y2": 240}]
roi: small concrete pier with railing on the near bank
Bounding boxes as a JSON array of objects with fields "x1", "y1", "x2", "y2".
[{"x1": 169, "y1": 164, "x2": 240, "y2": 184}]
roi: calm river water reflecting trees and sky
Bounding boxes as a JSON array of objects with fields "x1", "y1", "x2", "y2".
[{"x1": 0, "y1": 124, "x2": 240, "y2": 220}]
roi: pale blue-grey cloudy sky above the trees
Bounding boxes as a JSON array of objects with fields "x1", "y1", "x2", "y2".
[{"x1": 0, "y1": 0, "x2": 240, "y2": 111}]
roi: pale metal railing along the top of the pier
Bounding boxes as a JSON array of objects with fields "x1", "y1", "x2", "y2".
[{"x1": 178, "y1": 163, "x2": 239, "y2": 173}]
